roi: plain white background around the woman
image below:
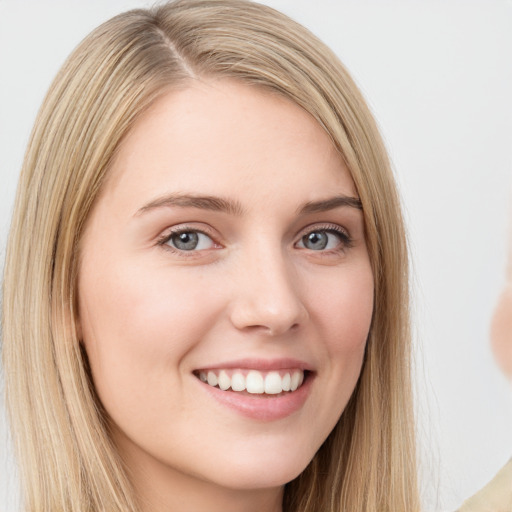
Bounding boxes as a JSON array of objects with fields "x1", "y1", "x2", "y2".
[{"x1": 0, "y1": 0, "x2": 512, "y2": 512}]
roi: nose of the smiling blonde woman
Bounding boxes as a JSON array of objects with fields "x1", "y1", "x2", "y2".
[{"x1": 231, "y1": 250, "x2": 308, "y2": 336}]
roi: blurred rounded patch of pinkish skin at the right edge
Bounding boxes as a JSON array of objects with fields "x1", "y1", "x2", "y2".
[{"x1": 491, "y1": 286, "x2": 512, "y2": 378}]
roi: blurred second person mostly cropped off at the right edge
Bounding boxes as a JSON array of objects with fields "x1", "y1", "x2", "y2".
[{"x1": 459, "y1": 225, "x2": 512, "y2": 512}]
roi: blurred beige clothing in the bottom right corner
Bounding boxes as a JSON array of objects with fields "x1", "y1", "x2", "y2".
[{"x1": 458, "y1": 459, "x2": 512, "y2": 512}]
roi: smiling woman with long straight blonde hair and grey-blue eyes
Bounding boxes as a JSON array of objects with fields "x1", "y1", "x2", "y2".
[{"x1": 3, "y1": 0, "x2": 419, "y2": 512}]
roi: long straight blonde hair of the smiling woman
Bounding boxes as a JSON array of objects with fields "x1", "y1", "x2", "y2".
[{"x1": 2, "y1": 0, "x2": 419, "y2": 512}]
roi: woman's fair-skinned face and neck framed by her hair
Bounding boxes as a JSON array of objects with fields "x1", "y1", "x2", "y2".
[{"x1": 79, "y1": 80, "x2": 373, "y2": 512}]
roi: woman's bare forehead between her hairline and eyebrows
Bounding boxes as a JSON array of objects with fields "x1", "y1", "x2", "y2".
[{"x1": 103, "y1": 80, "x2": 356, "y2": 211}]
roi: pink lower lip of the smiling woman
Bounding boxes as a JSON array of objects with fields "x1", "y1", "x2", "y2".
[{"x1": 197, "y1": 373, "x2": 314, "y2": 421}]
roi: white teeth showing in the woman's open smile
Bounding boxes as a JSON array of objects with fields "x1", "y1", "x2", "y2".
[{"x1": 194, "y1": 369, "x2": 309, "y2": 395}]
